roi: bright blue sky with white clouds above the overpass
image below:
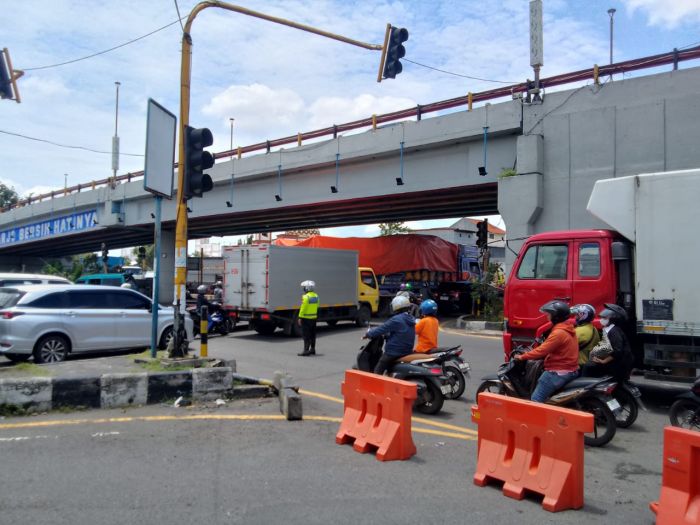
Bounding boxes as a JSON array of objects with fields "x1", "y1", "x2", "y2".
[{"x1": 0, "y1": 0, "x2": 700, "y2": 243}]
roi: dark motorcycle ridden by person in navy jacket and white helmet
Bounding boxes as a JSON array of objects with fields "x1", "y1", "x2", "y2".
[{"x1": 355, "y1": 337, "x2": 450, "y2": 414}]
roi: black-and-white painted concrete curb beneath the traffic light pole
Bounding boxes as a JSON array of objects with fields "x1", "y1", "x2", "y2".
[{"x1": 0, "y1": 362, "x2": 274, "y2": 413}]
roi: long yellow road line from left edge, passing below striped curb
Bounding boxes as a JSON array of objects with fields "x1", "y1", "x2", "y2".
[{"x1": 0, "y1": 414, "x2": 476, "y2": 441}]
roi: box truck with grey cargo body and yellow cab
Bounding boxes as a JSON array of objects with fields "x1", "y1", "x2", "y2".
[{"x1": 224, "y1": 244, "x2": 379, "y2": 335}]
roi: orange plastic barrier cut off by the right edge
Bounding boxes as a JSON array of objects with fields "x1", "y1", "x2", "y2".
[{"x1": 649, "y1": 427, "x2": 700, "y2": 525}]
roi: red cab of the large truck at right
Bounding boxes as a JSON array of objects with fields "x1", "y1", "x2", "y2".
[{"x1": 503, "y1": 230, "x2": 631, "y2": 356}]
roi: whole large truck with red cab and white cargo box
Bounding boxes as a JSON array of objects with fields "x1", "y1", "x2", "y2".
[{"x1": 503, "y1": 170, "x2": 700, "y2": 381}]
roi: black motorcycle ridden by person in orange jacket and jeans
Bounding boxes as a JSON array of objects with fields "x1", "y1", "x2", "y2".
[{"x1": 476, "y1": 347, "x2": 620, "y2": 447}]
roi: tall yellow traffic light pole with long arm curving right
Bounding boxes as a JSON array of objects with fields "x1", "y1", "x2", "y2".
[{"x1": 169, "y1": 1, "x2": 384, "y2": 357}]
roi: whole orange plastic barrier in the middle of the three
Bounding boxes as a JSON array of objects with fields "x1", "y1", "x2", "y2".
[{"x1": 472, "y1": 392, "x2": 593, "y2": 512}]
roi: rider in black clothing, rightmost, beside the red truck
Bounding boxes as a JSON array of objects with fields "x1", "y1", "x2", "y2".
[{"x1": 583, "y1": 303, "x2": 634, "y2": 381}]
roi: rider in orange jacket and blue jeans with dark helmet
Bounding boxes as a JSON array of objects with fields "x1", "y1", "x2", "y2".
[{"x1": 515, "y1": 300, "x2": 578, "y2": 403}]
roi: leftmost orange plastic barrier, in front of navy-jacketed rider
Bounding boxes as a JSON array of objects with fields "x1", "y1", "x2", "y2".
[{"x1": 335, "y1": 370, "x2": 417, "y2": 461}]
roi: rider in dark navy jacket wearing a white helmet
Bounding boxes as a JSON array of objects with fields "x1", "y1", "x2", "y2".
[{"x1": 363, "y1": 295, "x2": 416, "y2": 375}]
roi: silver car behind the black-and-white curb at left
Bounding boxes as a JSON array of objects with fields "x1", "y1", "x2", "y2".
[{"x1": 0, "y1": 285, "x2": 193, "y2": 363}]
